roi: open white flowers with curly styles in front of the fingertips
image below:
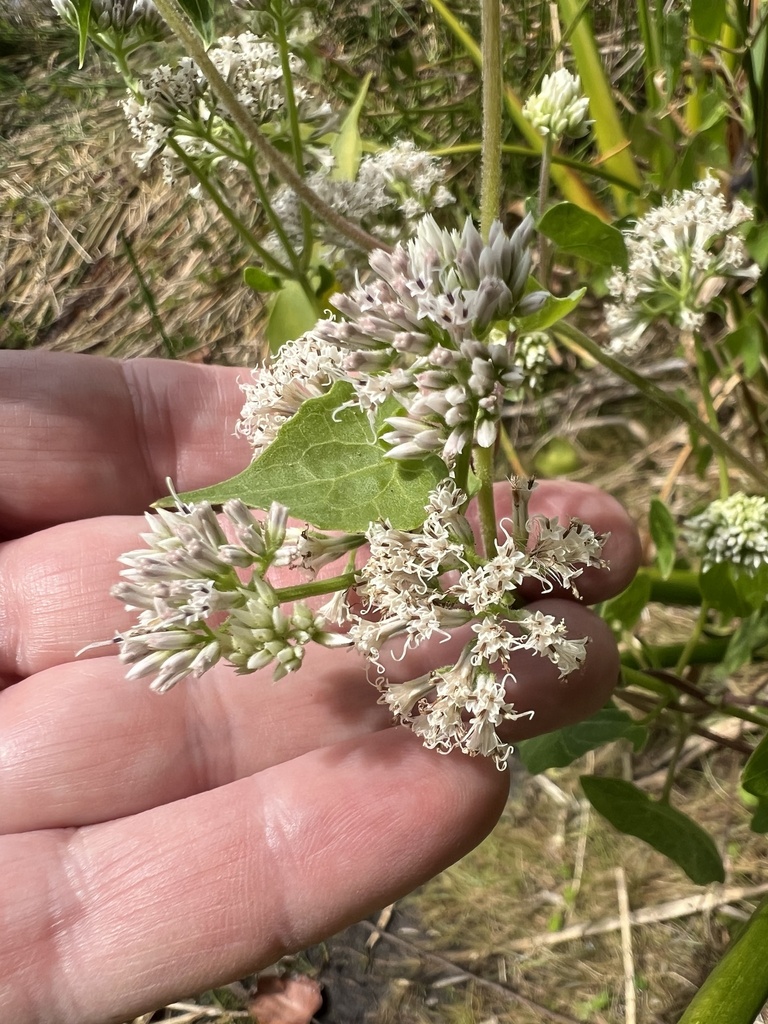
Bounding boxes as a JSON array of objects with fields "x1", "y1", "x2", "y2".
[{"x1": 356, "y1": 480, "x2": 604, "y2": 767}]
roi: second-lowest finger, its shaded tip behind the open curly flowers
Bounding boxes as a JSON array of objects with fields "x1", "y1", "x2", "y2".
[{"x1": 0, "y1": 601, "x2": 617, "y2": 834}]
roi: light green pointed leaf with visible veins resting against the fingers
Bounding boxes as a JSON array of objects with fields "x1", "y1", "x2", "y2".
[{"x1": 158, "y1": 381, "x2": 447, "y2": 534}]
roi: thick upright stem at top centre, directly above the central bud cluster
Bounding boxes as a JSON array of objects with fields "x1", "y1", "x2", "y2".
[{"x1": 480, "y1": 0, "x2": 504, "y2": 242}]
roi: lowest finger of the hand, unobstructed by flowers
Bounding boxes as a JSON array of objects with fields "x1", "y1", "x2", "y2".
[{"x1": 0, "y1": 730, "x2": 507, "y2": 1024}]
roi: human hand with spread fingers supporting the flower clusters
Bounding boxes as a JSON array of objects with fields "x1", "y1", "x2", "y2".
[{"x1": 0, "y1": 352, "x2": 639, "y2": 1024}]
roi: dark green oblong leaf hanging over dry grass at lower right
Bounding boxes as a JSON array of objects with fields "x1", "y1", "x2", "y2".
[{"x1": 581, "y1": 775, "x2": 725, "y2": 886}]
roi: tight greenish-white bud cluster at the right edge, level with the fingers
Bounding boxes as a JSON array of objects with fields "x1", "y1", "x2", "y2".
[{"x1": 685, "y1": 492, "x2": 768, "y2": 572}]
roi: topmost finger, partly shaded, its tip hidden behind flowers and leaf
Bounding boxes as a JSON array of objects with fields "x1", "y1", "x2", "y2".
[{"x1": 0, "y1": 351, "x2": 244, "y2": 537}]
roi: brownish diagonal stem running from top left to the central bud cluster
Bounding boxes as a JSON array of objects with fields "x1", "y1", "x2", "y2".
[{"x1": 156, "y1": 0, "x2": 390, "y2": 252}]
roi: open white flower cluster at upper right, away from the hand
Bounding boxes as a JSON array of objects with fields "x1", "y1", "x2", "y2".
[{"x1": 605, "y1": 177, "x2": 760, "y2": 354}]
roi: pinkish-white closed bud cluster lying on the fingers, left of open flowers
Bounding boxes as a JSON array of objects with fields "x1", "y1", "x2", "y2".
[{"x1": 113, "y1": 500, "x2": 360, "y2": 693}]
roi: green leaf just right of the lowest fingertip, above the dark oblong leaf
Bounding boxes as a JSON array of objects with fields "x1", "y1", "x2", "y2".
[{"x1": 515, "y1": 705, "x2": 647, "y2": 775}]
